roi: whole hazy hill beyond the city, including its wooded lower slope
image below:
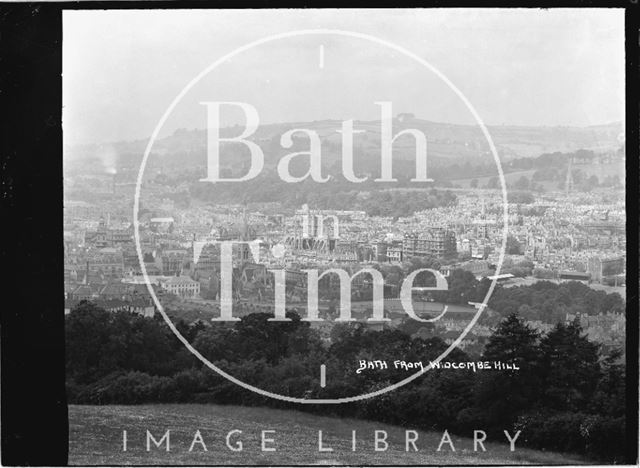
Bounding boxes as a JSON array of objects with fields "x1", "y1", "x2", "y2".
[{"x1": 65, "y1": 119, "x2": 624, "y2": 210}]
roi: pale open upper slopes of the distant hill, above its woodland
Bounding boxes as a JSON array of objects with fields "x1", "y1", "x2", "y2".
[{"x1": 65, "y1": 119, "x2": 624, "y2": 176}]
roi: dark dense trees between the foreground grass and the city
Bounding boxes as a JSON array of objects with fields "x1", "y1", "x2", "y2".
[{"x1": 66, "y1": 276, "x2": 625, "y2": 462}]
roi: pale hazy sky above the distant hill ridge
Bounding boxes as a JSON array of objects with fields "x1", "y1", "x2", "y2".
[{"x1": 63, "y1": 9, "x2": 624, "y2": 144}]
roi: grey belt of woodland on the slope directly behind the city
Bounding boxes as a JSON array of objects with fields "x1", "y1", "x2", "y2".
[{"x1": 154, "y1": 150, "x2": 622, "y2": 218}]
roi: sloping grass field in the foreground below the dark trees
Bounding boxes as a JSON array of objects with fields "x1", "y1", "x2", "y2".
[{"x1": 69, "y1": 404, "x2": 585, "y2": 466}]
